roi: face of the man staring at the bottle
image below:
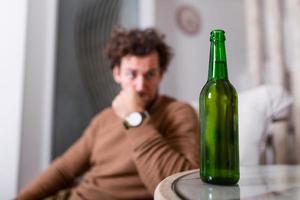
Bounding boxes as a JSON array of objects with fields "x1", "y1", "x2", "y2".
[{"x1": 113, "y1": 52, "x2": 162, "y2": 106}]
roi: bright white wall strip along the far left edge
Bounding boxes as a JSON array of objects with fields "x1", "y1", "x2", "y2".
[{"x1": 0, "y1": 0, "x2": 27, "y2": 199}]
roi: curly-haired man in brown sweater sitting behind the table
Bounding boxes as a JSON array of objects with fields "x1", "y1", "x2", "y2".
[{"x1": 17, "y1": 28, "x2": 199, "y2": 200}]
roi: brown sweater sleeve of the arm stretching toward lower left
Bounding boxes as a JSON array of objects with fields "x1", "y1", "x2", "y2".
[{"x1": 17, "y1": 115, "x2": 97, "y2": 200}]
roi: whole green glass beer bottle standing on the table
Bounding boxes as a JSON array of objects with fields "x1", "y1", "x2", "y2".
[{"x1": 199, "y1": 30, "x2": 240, "y2": 185}]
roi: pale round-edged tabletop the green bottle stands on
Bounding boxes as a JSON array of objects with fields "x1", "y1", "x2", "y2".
[{"x1": 154, "y1": 165, "x2": 300, "y2": 200}]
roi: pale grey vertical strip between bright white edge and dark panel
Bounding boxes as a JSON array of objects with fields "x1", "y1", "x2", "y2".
[{"x1": 19, "y1": 0, "x2": 57, "y2": 191}]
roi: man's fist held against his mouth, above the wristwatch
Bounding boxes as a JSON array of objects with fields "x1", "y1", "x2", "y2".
[{"x1": 112, "y1": 87, "x2": 145, "y2": 119}]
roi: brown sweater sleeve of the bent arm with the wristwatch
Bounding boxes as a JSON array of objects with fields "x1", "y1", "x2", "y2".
[{"x1": 127, "y1": 104, "x2": 199, "y2": 194}]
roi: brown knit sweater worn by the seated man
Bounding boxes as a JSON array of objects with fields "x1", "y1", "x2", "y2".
[{"x1": 17, "y1": 96, "x2": 199, "y2": 200}]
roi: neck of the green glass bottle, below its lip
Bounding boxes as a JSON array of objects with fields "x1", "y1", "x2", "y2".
[{"x1": 208, "y1": 40, "x2": 228, "y2": 81}]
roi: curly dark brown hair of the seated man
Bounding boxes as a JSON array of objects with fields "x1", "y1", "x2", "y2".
[{"x1": 105, "y1": 27, "x2": 173, "y2": 73}]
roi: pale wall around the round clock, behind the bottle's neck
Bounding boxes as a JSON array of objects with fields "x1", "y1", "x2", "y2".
[{"x1": 155, "y1": 0, "x2": 250, "y2": 102}]
